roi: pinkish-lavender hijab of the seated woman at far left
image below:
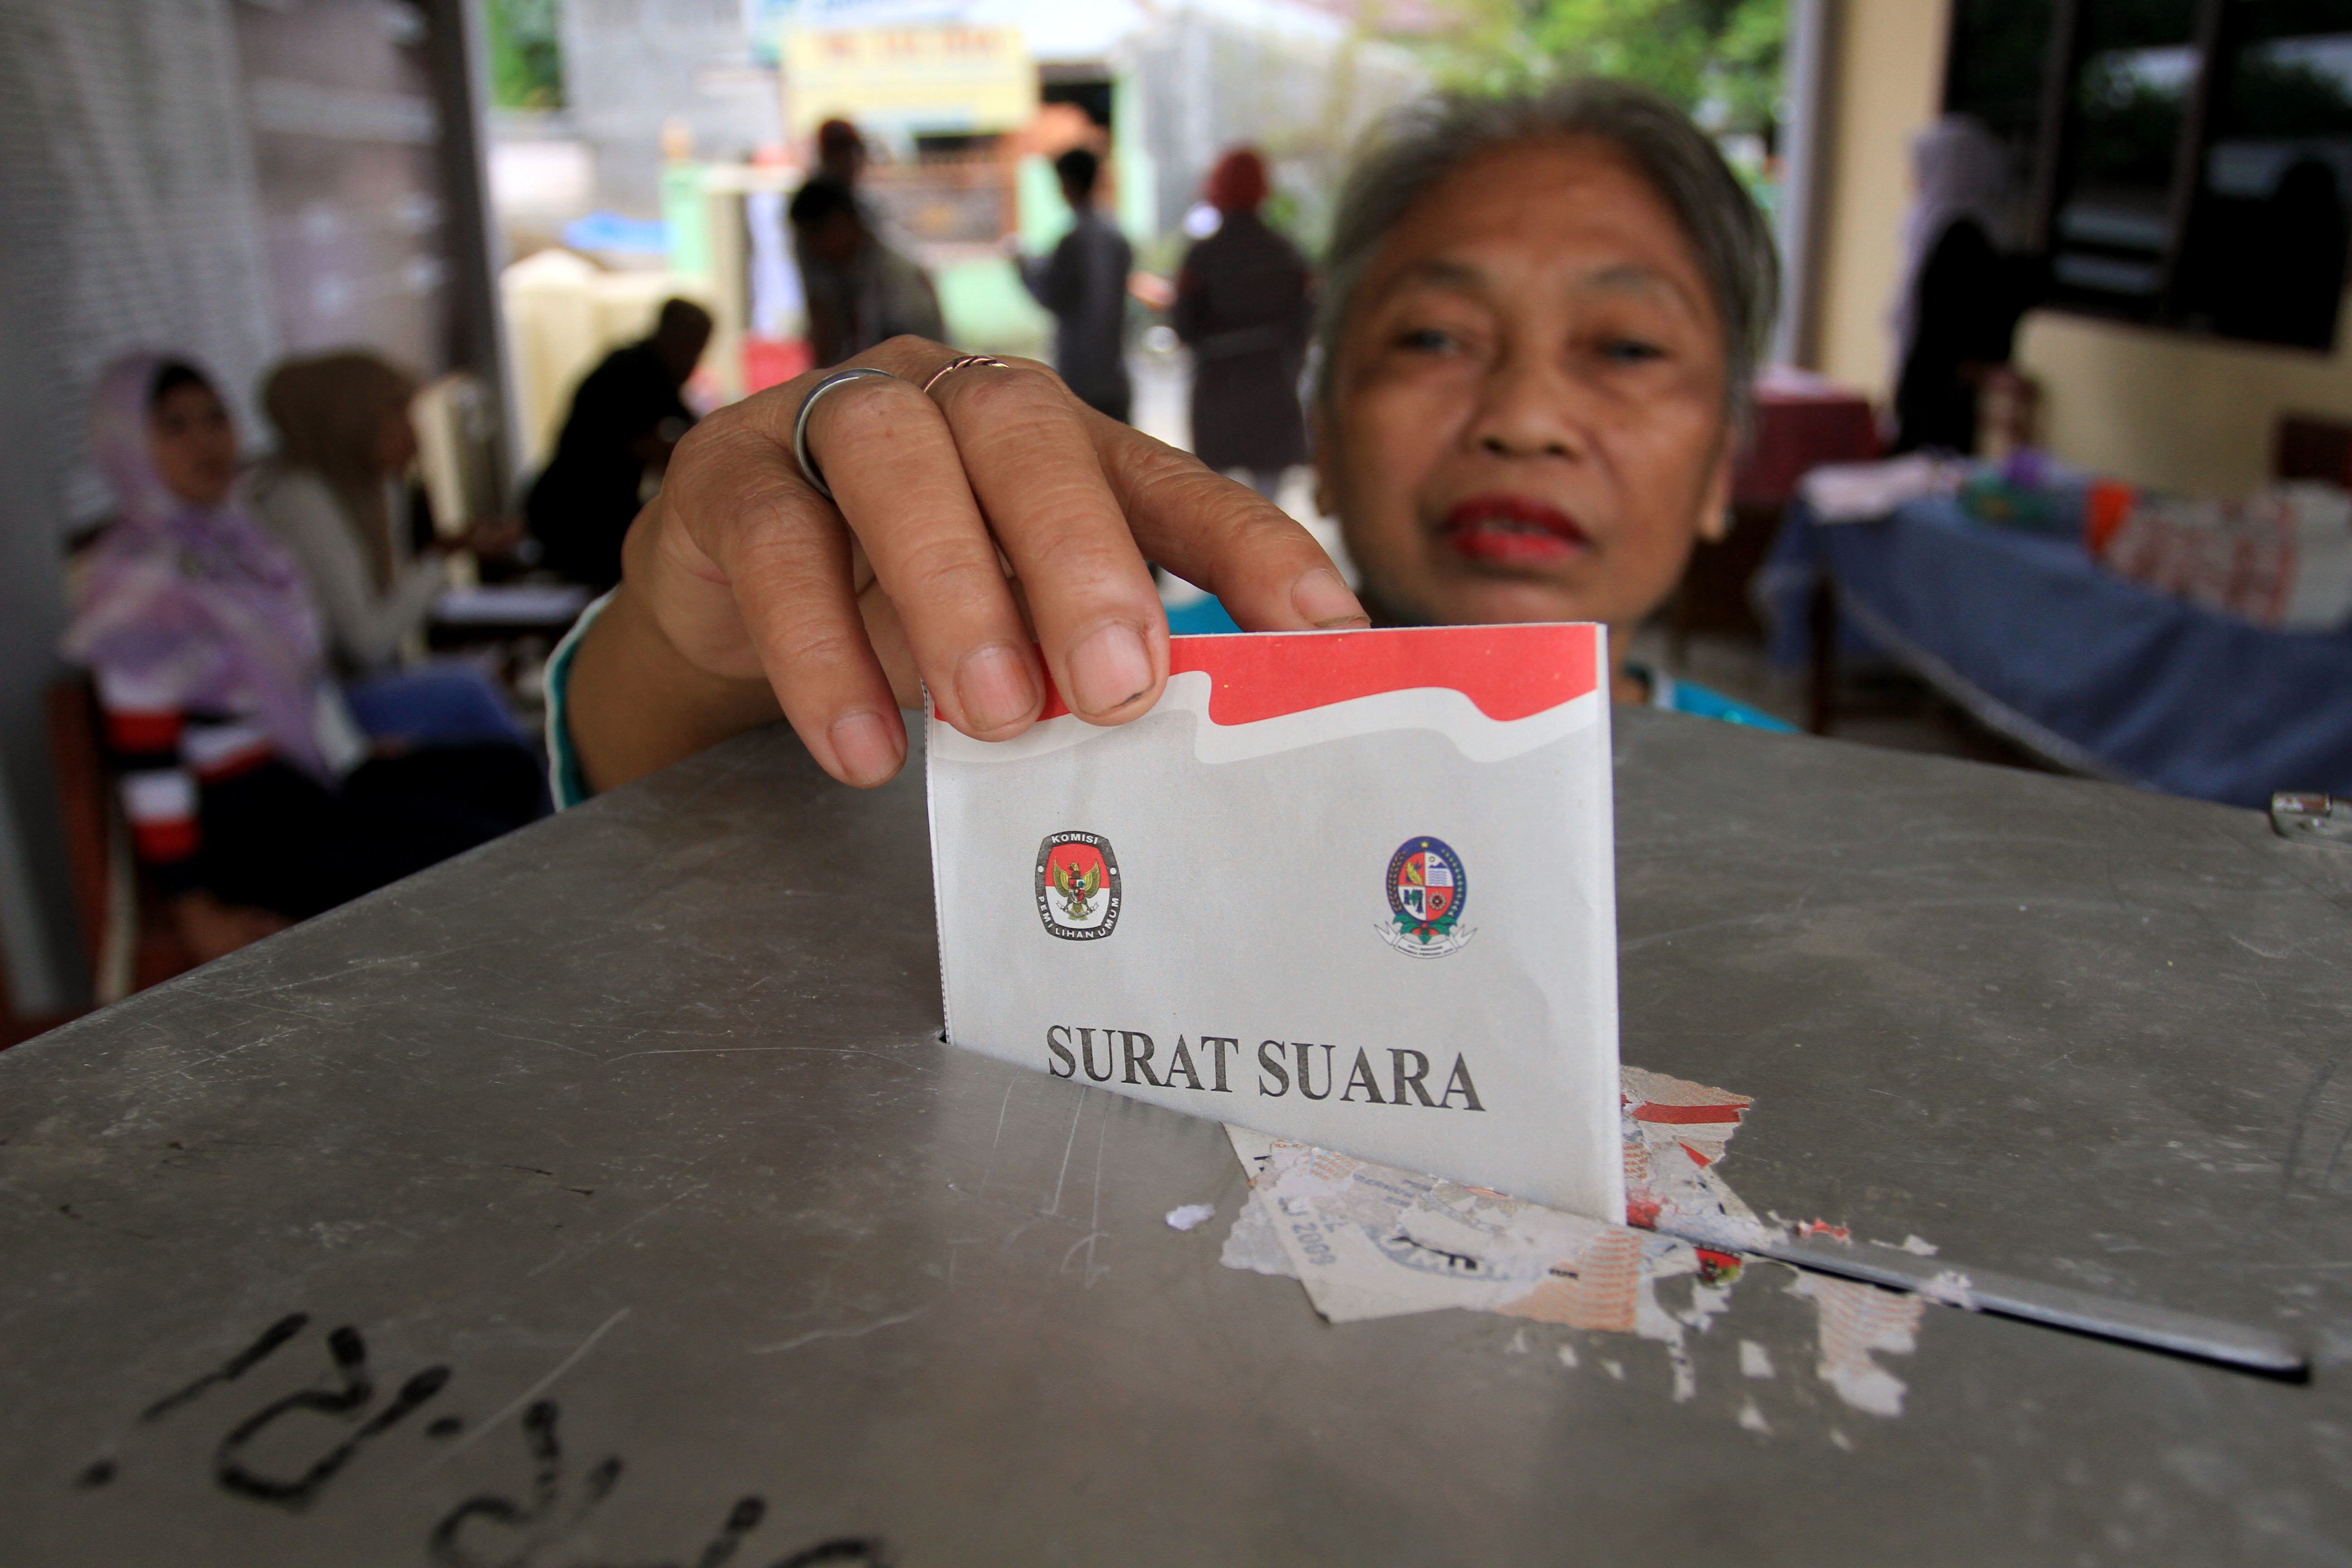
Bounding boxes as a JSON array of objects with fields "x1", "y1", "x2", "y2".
[{"x1": 61, "y1": 353, "x2": 334, "y2": 780}]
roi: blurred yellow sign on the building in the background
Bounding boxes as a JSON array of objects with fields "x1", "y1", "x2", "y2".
[{"x1": 783, "y1": 24, "x2": 1037, "y2": 137}]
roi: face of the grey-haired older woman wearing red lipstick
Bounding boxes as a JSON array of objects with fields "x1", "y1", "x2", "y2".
[{"x1": 1317, "y1": 139, "x2": 1731, "y2": 630}]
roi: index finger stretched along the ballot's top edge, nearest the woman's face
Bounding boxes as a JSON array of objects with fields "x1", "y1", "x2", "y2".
[{"x1": 1094, "y1": 416, "x2": 1371, "y2": 632}]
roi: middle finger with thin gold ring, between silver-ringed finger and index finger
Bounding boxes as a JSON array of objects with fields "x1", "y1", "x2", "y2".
[{"x1": 936, "y1": 364, "x2": 1169, "y2": 724}]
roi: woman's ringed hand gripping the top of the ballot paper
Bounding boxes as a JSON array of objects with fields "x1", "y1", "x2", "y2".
[{"x1": 569, "y1": 338, "x2": 1367, "y2": 788}]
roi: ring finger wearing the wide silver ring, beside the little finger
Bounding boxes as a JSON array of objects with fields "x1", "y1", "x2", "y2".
[{"x1": 809, "y1": 378, "x2": 1044, "y2": 740}]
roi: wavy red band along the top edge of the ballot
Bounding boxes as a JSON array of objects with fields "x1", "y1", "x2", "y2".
[{"x1": 1037, "y1": 625, "x2": 1599, "y2": 724}]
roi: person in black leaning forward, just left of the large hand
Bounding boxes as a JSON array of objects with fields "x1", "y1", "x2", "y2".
[{"x1": 524, "y1": 299, "x2": 710, "y2": 590}]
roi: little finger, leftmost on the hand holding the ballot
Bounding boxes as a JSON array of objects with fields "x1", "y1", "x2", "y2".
[{"x1": 656, "y1": 421, "x2": 906, "y2": 788}]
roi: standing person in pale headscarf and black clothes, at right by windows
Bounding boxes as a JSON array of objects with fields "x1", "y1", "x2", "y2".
[{"x1": 1893, "y1": 115, "x2": 2025, "y2": 456}]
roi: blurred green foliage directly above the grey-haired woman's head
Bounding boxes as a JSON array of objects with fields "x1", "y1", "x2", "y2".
[{"x1": 1430, "y1": 0, "x2": 1788, "y2": 132}]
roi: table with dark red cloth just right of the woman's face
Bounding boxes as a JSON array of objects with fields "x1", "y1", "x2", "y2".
[{"x1": 1670, "y1": 367, "x2": 1879, "y2": 658}]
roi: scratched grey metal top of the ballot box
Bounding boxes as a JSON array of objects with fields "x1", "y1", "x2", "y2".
[{"x1": 0, "y1": 715, "x2": 2352, "y2": 1568}]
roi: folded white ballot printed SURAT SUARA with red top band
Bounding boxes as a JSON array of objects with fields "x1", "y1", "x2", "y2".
[{"x1": 926, "y1": 625, "x2": 1625, "y2": 1222}]
